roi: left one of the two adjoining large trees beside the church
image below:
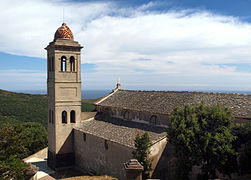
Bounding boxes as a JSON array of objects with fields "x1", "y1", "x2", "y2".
[{"x1": 167, "y1": 105, "x2": 200, "y2": 180}]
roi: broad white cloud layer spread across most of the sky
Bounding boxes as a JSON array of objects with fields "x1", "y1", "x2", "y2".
[{"x1": 0, "y1": 0, "x2": 251, "y2": 89}]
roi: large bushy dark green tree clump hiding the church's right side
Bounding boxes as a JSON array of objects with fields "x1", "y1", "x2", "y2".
[{"x1": 167, "y1": 104, "x2": 236, "y2": 179}]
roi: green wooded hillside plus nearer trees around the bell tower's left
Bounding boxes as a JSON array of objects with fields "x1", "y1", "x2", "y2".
[{"x1": 0, "y1": 90, "x2": 97, "y2": 180}]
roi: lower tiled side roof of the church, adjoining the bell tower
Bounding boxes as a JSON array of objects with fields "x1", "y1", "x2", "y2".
[{"x1": 74, "y1": 117, "x2": 166, "y2": 148}]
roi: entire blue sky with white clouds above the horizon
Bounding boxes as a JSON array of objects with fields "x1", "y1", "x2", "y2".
[{"x1": 0, "y1": 0, "x2": 251, "y2": 91}]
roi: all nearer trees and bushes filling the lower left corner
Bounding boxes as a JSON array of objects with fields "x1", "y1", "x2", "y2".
[{"x1": 0, "y1": 123, "x2": 47, "y2": 180}]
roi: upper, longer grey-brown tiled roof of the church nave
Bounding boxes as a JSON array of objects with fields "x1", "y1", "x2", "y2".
[{"x1": 96, "y1": 89, "x2": 251, "y2": 119}]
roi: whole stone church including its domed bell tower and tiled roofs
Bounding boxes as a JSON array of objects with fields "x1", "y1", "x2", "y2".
[{"x1": 45, "y1": 23, "x2": 251, "y2": 179}]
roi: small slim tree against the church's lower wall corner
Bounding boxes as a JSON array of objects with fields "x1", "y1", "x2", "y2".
[{"x1": 132, "y1": 133, "x2": 152, "y2": 179}]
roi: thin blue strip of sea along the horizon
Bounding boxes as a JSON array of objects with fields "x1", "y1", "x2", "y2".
[{"x1": 15, "y1": 89, "x2": 251, "y2": 99}]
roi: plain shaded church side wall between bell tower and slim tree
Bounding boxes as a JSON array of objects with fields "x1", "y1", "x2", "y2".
[{"x1": 74, "y1": 129, "x2": 133, "y2": 179}]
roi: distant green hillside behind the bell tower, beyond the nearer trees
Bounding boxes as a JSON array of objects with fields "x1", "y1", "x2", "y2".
[{"x1": 0, "y1": 89, "x2": 96, "y2": 127}]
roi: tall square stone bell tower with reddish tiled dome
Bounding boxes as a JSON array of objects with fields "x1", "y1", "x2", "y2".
[{"x1": 45, "y1": 23, "x2": 83, "y2": 169}]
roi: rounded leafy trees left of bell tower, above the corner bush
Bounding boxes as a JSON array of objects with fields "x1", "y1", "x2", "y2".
[{"x1": 0, "y1": 123, "x2": 47, "y2": 160}]
